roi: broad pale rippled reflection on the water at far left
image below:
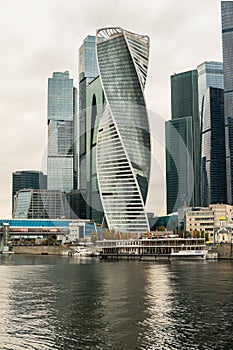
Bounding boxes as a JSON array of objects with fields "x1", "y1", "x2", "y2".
[{"x1": 4, "y1": 265, "x2": 59, "y2": 349}]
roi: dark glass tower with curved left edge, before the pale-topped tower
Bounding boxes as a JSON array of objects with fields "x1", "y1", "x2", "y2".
[{"x1": 201, "y1": 87, "x2": 227, "y2": 207}]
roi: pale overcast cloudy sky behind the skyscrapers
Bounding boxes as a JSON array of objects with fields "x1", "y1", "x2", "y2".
[{"x1": 0, "y1": 0, "x2": 222, "y2": 218}]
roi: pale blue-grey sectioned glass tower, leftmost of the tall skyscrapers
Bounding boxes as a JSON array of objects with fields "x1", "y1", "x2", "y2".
[{"x1": 47, "y1": 71, "x2": 76, "y2": 192}]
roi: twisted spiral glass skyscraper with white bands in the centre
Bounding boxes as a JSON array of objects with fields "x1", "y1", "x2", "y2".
[{"x1": 96, "y1": 28, "x2": 150, "y2": 232}]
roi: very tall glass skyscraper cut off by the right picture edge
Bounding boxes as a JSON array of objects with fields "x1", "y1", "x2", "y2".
[{"x1": 221, "y1": 1, "x2": 233, "y2": 204}]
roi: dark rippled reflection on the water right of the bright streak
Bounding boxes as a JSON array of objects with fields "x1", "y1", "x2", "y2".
[{"x1": 167, "y1": 261, "x2": 233, "y2": 350}]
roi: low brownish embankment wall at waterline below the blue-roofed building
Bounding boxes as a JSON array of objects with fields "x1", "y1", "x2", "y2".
[{"x1": 12, "y1": 246, "x2": 68, "y2": 255}]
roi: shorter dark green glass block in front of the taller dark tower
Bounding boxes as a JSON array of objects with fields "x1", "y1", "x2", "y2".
[{"x1": 165, "y1": 117, "x2": 195, "y2": 213}]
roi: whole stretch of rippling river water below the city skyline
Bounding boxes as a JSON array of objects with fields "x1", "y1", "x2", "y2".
[{"x1": 0, "y1": 255, "x2": 233, "y2": 350}]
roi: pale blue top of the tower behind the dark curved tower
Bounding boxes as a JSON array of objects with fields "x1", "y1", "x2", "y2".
[{"x1": 197, "y1": 61, "x2": 223, "y2": 115}]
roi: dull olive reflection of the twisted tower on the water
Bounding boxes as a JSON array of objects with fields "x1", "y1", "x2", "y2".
[{"x1": 98, "y1": 262, "x2": 146, "y2": 350}]
